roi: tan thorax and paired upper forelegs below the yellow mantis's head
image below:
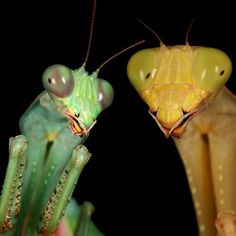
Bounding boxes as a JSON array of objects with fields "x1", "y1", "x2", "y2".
[{"x1": 175, "y1": 88, "x2": 236, "y2": 236}]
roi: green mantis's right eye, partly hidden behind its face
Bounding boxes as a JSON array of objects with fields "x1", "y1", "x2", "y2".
[{"x1": 97, "y1": 79, "x2": 114, "y2": 110}]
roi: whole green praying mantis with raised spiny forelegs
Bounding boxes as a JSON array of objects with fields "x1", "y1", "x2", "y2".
[{"x1": 0, "y1": 1, "x2": 113, "y2": 236}]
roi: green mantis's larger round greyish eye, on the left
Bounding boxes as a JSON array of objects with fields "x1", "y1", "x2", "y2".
[{"x1": 42, "y1": 65, "x2": 74, "y2": 98}]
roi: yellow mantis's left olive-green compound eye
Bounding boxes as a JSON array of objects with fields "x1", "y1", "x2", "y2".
[{"x1": 127, "y1": 49, "x2": 157, "y2": 93}]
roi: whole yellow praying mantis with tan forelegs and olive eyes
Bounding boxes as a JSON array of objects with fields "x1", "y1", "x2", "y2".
[{"x1": 127, "y1": 21, "x2": 236, "y2": 236}]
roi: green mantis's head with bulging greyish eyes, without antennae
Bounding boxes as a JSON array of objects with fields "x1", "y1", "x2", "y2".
[{"x1": 42, "y1": 65, "x2": 114, "y2": 136}]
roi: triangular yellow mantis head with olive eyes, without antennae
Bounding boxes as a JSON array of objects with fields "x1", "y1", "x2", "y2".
[{"x1": 127, "y1": 45, "x2": 232, "y2": 137}]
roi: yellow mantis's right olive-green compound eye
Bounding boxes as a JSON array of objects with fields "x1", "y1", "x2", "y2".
[{"x1": 193, "y1": 47, "x2": 232, "y2": 91}]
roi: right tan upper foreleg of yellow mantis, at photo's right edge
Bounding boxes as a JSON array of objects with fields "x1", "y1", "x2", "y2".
[{"x1": 209, "y1": 93, "x2": 236, "y2": 211}]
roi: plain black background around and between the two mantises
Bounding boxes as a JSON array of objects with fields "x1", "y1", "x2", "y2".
[{"x1": 0, "y1": 0, "x2": 236, "y2": 236}]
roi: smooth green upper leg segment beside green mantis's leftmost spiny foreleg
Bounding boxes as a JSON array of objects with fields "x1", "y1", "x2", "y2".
[{"x1": 14, "y1": 106, "x2": 48, "y2": 235}]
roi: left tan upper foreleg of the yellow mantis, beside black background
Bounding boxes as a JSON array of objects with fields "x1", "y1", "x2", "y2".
[{"x1": 175, "y1": 127, "x2": 216, "y2": 236}]
